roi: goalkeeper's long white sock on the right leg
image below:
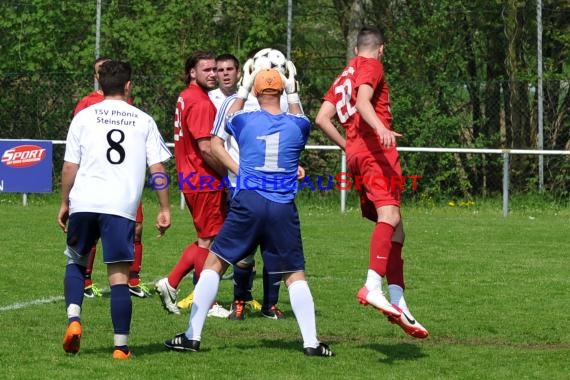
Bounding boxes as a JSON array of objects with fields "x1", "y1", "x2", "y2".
[{"x1": 287, "y1": 280, "x2": 319, "y2": 348}]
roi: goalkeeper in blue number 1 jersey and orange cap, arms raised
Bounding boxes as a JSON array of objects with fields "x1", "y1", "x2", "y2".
[{"x1": 164, "y1": 61, "x2": 334, "y2": 357}]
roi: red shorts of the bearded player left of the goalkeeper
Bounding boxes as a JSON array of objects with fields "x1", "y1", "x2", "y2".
[{"x1": 184, "y1": 191, "x2": 228, "y2": 239}]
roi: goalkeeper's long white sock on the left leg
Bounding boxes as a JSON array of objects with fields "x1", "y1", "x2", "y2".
[{"x1": 186, "y1": 269, "x2": 220, "y2": 341}]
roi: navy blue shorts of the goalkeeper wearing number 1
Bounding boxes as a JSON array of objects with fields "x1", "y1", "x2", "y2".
[{"x1": 211, "y1": 190, "x2": 305, "y2": 273}]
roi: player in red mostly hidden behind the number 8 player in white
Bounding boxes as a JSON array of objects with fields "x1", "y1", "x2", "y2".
[{"x1": 73, "y1": 57, "x2": 150, "y2": 298}]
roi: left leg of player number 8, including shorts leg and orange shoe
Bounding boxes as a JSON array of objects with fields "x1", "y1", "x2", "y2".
[{"x1": 63, "y1": 213, "x2": 99, "y2": 354}]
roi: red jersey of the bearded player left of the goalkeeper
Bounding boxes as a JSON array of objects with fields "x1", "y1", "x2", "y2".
[{"x1": 174, "y1": 83, "x2": 221, "y2": 193}]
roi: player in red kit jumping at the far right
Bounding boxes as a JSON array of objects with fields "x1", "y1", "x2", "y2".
[{"x1": 315, "y1": 27, "x2": 428, "y2": 338}]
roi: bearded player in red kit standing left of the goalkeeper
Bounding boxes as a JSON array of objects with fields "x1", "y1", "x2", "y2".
[{"x1": 156, "y1": 51, "x2": 229, "y2": 317}]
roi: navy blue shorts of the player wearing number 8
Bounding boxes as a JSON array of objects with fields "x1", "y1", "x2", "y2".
[{"x1": 65, "y1": 212, "x2": 135, "y2": 264}]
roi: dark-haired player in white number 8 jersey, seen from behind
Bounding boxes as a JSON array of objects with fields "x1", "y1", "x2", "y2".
[{"x1": 58, "y1": 61, "x2": 172, "y2": 359}]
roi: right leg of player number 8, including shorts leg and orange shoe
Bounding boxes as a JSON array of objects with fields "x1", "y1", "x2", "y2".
[{"x1": 99, "y1": 214, "x2": 135, "y2": 360}]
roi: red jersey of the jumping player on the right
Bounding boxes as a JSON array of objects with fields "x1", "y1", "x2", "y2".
[{"x1": 324, "y1": 57, "x2": 392, "y2": 155}]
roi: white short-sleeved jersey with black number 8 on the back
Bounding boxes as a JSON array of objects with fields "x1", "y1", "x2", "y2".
[{"x1": 64, "y1": 100, "x2": 172, "y2": 220}]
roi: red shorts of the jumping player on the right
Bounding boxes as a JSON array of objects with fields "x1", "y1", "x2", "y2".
[{"x1": 347, "y1": 148, "x2": 403, "y2": 222}]
